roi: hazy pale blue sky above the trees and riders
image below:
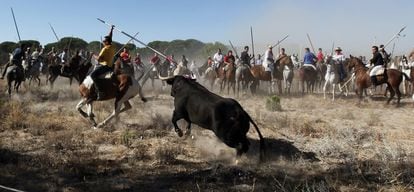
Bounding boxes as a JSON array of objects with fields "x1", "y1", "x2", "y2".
[{"x1": 0, "y1": 0, "x2": 414, "y2": 55}]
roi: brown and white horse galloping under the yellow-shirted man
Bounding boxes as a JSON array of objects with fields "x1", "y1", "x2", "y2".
[{"x1": 76, "y1": 62, "x2": 147, "y2": 128}]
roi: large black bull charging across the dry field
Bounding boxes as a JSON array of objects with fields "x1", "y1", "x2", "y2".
[{"x1": 167, "y1": 76, "x2": 265, "y2": 160}]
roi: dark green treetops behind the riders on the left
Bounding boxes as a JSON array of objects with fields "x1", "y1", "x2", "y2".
[{"x1": 0, "y1": 37, "x2": 228, "y2": 64}]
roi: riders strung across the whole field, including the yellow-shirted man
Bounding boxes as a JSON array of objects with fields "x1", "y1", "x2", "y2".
[{"x1": 1, "y1": 28, "x2": 414, "y2": 100}]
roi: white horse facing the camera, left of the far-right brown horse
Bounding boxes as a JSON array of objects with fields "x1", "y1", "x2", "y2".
[{"x1": 323, "y1": 57, "x2": 342, "y2": 101}]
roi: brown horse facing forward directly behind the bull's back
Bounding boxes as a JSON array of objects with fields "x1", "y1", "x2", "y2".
[{"x1": 218, "y1": 61, "x2": 236, "y2": 95}]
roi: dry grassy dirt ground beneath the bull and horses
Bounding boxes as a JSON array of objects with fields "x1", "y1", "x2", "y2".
[{"x1": 0, "y1": 79, "x2": 414, "y2": 192}]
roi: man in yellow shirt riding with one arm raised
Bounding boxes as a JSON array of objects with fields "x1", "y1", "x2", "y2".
[{"x1": 90, "y1": 25, "x2": 115, "y2": 100}]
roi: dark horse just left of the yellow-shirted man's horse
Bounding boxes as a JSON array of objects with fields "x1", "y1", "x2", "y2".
[{"x1": 48, "y1": 55, "x2": 92, "y2": 88}]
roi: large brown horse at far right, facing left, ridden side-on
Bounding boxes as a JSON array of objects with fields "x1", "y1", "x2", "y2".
[{"x1": 348, "y1": 55, "x2": 410, "y2": 106}]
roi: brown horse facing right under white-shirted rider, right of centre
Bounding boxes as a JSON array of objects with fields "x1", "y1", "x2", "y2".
[{"x1": 250, "y1": 56, "x2": 293, "y2": 94}]
